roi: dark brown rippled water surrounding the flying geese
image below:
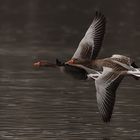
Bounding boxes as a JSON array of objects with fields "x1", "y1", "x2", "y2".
[{"x1": 0, "y1": 0, "x2": 140, "y2": 140}]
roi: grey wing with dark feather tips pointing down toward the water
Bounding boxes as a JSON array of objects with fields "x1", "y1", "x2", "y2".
[{"x1": 95, "y1": 67, "x2": 124, "y2": 122}]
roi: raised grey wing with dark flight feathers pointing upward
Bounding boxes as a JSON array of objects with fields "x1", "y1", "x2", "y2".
[{"x1": 72, "y1": 12, "x2": 106, "y2": 60}]
